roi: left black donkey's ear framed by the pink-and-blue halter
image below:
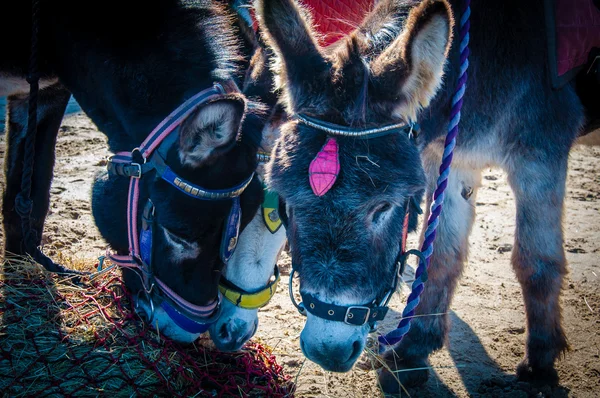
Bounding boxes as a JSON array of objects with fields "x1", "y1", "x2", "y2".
[{"x1": 179, "y1": 98, "x2": 245, "y2": 168}]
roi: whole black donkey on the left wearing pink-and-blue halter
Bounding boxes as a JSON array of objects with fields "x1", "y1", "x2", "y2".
[{"x1": 0, "y1": 0, "x2": 263, "y2": 342}]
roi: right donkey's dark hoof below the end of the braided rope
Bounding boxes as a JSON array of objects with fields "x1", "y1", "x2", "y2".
[{"x1": 377, "y1": 360, "x2": 429, "y2": 395}]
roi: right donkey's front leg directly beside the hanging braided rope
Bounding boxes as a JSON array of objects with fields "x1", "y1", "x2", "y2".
[{"x1": 379, "y1": 150, "x2": 481, "y2": 393}]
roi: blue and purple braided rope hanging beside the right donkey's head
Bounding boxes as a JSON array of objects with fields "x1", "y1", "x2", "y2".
[{"x1": 378, "y1": 0, "x2": 471, "y2": 346}]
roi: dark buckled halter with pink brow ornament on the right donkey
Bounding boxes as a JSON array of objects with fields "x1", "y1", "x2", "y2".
[{"x1": 280, "y1": 114, "x2": 422, "y2": 332}]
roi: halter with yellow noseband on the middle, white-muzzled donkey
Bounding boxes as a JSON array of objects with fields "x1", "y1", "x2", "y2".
[{"x1": 219, "y1": 152, "x2": 281, "y2": 310}]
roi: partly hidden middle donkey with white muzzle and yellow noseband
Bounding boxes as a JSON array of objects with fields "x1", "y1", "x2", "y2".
[{"x1": 210, "y1": 34, "x2": 286, "y2": 351}]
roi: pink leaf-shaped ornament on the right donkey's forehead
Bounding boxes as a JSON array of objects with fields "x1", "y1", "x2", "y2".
[{"x1": 308, "y1": 138, "x2": 340, "y2": 196}]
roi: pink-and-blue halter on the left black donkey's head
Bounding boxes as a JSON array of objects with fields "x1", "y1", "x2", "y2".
[{"x1": 107, "y1": 81, "x2": 254, "y2": 333}]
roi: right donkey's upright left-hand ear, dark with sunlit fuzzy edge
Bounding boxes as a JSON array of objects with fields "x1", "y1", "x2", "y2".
[{"x1": 256, "y1": 0, "x2": 330, "y2": 109}]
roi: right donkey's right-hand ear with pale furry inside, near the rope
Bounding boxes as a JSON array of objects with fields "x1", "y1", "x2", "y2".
[{"x1": 371, "y1": 0, "x2": 454, "y2": 120}]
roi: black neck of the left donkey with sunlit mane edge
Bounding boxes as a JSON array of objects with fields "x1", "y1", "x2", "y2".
[{"x1": 41, "y1": 0, "x2": 242, "y2": 151}]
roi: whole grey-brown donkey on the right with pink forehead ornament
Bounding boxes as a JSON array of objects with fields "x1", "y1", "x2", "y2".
[{"x1": 257, "y1": 0, "x2": 596, "y2": 392}]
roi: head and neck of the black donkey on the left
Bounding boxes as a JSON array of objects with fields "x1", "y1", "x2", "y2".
[{"x1": 81, "y1": 1, "x2": 262, "y2": 342}]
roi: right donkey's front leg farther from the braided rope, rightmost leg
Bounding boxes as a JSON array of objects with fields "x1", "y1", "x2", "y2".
[{"x1": 507, "y1": 155, "x2": 568, "y2": 383}]
